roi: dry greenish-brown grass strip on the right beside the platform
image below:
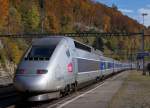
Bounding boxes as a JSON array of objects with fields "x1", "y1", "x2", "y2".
[{"x1": 109, "y1": 71, "x2": 150, "y2": 108}]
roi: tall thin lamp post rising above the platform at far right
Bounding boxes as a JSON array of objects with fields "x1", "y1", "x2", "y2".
[{"x1": 141, "y1": 13, "x2": 148, "y2": 75}]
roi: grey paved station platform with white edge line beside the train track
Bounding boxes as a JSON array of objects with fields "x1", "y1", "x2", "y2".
[{"x1": 57, "y1": 71, "x2": 129, "y2": 108}]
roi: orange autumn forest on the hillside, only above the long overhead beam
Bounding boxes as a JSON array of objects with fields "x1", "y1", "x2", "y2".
[{"x1": 0, "y1": 0, "x2": 145, "y2": 33}]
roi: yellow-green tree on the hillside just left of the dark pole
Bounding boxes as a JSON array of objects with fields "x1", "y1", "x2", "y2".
[{"x1": 20, "y1": 1, "x2": 40, "y2": 33}]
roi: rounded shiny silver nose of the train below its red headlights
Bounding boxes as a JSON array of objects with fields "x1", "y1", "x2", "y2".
[{"x1": 14, "y1": 75, "x2": 47, "y2": 92}]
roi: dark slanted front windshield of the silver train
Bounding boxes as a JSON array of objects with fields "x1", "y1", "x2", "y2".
[{"x1": 26, "y1": 46, "x2": 56, "y2": 60}]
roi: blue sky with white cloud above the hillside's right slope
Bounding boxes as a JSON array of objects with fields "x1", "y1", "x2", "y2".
[{"x1": 96, "y1": 0, "x2": 150, "y2": 26}]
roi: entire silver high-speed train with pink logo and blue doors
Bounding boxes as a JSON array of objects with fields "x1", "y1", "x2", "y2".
[{"x1": 14, "y1": 36, "x2": 131, "y2": 101}]
